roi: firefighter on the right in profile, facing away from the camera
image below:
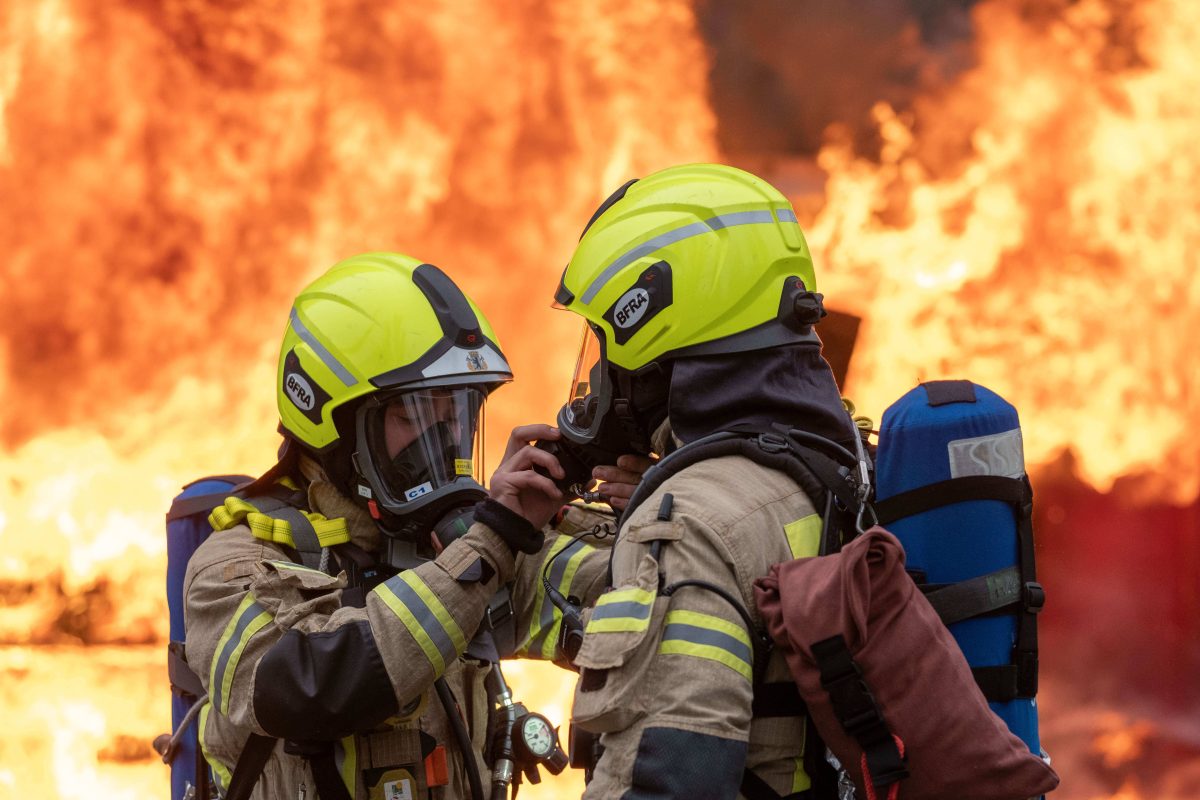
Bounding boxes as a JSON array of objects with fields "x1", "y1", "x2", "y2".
[{"x1": 535, "y1": 164, "x2": 856, "y2": 800}]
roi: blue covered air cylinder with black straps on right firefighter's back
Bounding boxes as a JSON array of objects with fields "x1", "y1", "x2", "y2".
[{"x1": 875, "y1": 380, "x2": 1044, "y2": 754}]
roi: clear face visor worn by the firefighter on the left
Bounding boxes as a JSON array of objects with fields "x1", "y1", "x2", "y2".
[{"x1": 364, "y1": 386, "x2": 486, "y2": 505}]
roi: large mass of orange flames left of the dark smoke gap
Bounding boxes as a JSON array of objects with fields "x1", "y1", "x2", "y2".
[{"x1": 0, "y1": 0, "x2": 715, "y2": 798}]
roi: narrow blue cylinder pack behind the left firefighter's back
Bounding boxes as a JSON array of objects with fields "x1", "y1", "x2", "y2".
[{"x1": 155, "y1": 475, "x2": 251, "y2": 800}]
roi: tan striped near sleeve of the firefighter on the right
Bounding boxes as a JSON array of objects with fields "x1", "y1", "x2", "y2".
[{"x1": 572, "y1": 457, "x2": 815, "y2": 800}]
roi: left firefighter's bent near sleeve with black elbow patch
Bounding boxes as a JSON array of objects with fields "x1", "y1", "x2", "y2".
[{"x1": 184, "y1": 525, "x2": 514, "y2": 740}]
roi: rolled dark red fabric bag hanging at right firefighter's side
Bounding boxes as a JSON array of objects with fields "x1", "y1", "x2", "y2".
[{"x1": 755, "y1": 528, "x2": 1058, "y2": 800}]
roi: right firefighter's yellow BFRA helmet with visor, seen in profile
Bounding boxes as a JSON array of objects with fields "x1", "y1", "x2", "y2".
[{"x1": 554, "y1": 164, "x2": 824, "y2": 450}]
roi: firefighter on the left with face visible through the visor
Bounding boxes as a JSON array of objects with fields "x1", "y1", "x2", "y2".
[{"x1": 185, "y1": 253, "x2": 643, "y2": 800}]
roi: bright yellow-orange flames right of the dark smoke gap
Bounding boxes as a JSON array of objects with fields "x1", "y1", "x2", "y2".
[{"x1": 809, "y1": 0, "x2": 1200, "y2": 503}]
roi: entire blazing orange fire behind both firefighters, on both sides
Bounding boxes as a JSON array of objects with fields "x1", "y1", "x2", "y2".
[{"x1": 0, "y1": 0, "x2": 1200, "y2": 798}]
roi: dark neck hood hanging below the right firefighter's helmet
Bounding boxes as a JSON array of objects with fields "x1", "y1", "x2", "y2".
[{"x1": 668, "y1": 343, "x2": 854, "y2": 451}]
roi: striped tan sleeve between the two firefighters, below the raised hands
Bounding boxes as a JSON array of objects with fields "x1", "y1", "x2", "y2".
[{"x1": 512, "y1": 505, "x2": 617, "y2": 668}]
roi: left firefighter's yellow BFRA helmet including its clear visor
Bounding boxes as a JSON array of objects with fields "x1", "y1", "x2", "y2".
[{"x1": 276, "y1": 252, "x2": 512, "y2": 525}]
